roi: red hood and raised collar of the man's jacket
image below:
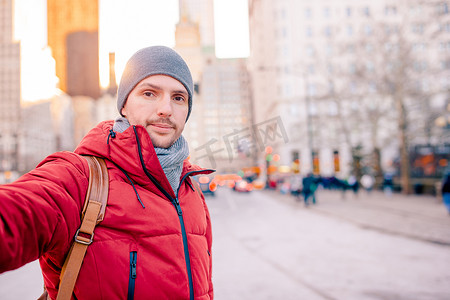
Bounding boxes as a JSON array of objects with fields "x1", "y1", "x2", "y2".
[{"x1": 75, "y1": 120, "x2": 213, "y2": 197}]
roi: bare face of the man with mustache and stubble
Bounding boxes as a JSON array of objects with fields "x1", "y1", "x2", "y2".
[{"x1": 122, "y1": 75, "x2": 189, "y2": 148}]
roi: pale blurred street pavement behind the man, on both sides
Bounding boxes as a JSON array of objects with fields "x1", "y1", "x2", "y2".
[{"x1": 0, "y1": 189, "x2": 450, "y2": 300}]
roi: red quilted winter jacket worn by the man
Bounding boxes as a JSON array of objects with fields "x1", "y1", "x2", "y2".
[{"x1": 0, "y1": 121, "x2": 213, "y2": 300}]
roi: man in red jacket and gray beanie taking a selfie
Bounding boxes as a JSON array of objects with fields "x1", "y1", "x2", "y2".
[{"x1": 0, "y1": 46, "x2": 213, "y2": 300}]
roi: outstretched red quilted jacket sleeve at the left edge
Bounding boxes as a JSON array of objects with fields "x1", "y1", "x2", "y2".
[{"x1": 0, "y1": 152, "x2": 89, "y2": 273}]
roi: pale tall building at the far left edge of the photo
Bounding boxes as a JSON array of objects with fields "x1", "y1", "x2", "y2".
[{"x1": 0, "y1": 0, "x2": 20, "y2": 182}]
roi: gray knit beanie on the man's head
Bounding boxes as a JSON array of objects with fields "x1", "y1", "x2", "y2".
[{"x1": 117, "y1": 46, "x2": 194, "y2": 121}]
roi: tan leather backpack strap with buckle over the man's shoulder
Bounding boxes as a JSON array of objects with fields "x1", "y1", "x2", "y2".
[{"x1": 56, "y1": 156, "x2": 109, "y2": 300}]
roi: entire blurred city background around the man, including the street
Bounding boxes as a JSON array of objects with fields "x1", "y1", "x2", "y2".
[{"x1": 0, "y1": 0, "x2": 450, "y2": 299}]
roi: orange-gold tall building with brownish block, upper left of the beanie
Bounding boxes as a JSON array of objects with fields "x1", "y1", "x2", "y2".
[{"x1": 47, "y1": 0, "x2": 100, "y2": 99}]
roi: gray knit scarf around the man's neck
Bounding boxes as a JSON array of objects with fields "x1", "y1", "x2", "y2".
[{"x1": 113, "y1": 117, "x2": 189, "y2": 195}]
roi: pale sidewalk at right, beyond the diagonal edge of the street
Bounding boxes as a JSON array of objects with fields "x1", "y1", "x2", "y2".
[{"x1": 265, "y1": 189, "x2": 450, "y2": 246}]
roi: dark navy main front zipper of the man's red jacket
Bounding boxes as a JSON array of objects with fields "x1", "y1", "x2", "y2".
[{"x1": 133, "y1": 126, "x2": 215, "y2": 300}]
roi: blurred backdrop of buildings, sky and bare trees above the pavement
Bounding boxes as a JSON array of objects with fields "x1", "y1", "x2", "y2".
[{"x1": 0, "y1": 0, "x2": 450, "y2": 194}]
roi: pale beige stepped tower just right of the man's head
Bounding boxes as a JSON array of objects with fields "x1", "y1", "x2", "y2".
[{"x1": 175, "y1": 1, "x2": 253, "y2": 172}]
